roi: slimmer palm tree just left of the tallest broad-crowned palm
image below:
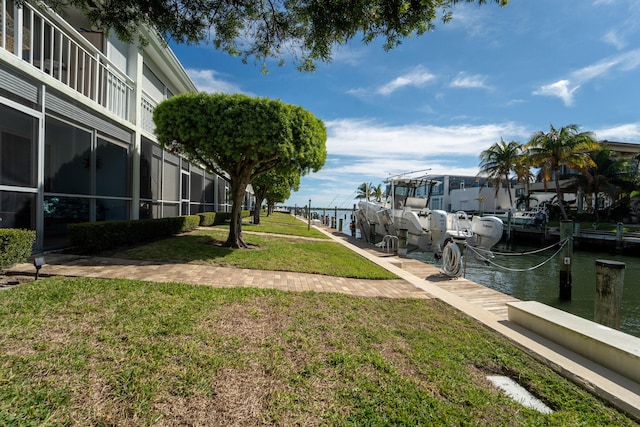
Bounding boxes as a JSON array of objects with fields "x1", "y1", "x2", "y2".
[{"x1": 480, "y1": 138, "x2": 522, "y2": 206}]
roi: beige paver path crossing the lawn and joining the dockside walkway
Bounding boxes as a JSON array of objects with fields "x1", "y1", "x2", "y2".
[{"x1": 9, "y1": 230, "x2": 517, "y2": 319}]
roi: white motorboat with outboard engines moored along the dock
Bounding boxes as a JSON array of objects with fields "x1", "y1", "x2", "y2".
[{"x1": 355, "y1": 175, "x2": 503, "y2": 257}]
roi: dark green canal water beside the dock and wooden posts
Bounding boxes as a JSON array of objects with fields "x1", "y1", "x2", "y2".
[{"x1": 409, "y1": 244, "x2": 640, "y2": 337}]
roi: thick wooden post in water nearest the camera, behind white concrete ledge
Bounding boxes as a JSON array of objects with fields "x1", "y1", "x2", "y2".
[{"x1": 594, "y1": 259, "x2": 626, "y2": 330}]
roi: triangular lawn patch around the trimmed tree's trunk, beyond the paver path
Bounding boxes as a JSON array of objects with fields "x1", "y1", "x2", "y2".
[{"x1": 113, "y1": 214, "x2": 397, "y2": 279}]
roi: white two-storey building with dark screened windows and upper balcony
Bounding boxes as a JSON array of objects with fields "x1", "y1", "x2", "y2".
[{"x1": 0, "y1": 0, "x2": 251, "y2": 251}]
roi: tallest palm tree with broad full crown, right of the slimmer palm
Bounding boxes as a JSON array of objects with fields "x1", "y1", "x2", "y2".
[{"x1": 526, "y1": 124, "x2": 600, "y2": 220}]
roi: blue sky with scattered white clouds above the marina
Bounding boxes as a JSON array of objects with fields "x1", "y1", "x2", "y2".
[{"x1": 172, "y1": 0, "x2": 640, "y2": 208}]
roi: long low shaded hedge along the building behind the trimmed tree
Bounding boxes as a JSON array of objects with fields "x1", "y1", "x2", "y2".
[{"x1": 68, "y1": 215, "x2": 200, "y2": 253}]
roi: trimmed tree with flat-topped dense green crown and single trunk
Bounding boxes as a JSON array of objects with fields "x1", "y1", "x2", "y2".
[{"x1": 153, "y1": 93, "x2": 327, "y2": 248}]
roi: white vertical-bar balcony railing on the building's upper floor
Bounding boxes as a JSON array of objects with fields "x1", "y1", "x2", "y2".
[{"x1": 0, "y1": 0, "x2": 133, "y2": 120}]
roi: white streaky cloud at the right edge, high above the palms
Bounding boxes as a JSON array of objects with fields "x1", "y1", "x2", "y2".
[{"x1": 533, "y1": 49, "x2": 640, "y2": 106}]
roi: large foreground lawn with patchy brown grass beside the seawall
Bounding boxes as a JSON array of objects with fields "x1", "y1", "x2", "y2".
[{"x1": 0, "y1": 278, "x2": 635, "y2": 426}]
